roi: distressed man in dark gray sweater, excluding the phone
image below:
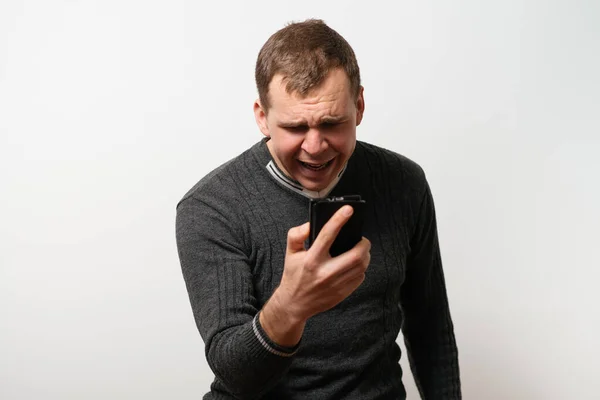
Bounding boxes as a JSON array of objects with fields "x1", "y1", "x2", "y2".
[{"x1": 177, "y1": 20, "x2": 461, "y2": 400}]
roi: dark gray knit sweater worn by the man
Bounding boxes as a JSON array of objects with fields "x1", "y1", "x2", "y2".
[{"x1": 176, "y1": 140, "x2": 461, "y2": 400}]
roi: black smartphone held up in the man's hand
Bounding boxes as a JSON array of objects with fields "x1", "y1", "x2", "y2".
[{"x1": 308, "y1": 195, "x2": 366, "y2": 257}]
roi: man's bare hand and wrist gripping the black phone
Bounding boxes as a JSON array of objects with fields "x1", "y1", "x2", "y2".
[{"x1": 260, "y1": 205, "x2": 371, "y2": 346}]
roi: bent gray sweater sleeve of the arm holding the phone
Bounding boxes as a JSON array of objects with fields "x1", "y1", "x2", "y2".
[{"x1": 176, "y1": 197, "x2": 296, "y2": 399}]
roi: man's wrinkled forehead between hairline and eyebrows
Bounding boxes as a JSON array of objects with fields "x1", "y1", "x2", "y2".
[{"x1": 269, "y1": 69, "x2": 353, "y2": 118}]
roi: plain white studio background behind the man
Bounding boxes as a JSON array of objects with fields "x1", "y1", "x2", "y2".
[{"x1": 0, "y1": 0, "x2": 600, "y2": 400}]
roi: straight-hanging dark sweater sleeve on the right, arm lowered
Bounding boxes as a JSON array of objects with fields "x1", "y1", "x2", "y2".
[{"x1": 401, "y1": 181, "x2": 461, "y2": 400}]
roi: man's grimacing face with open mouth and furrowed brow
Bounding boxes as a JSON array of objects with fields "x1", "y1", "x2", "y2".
[{"x1": 254, "y1": 69, "x2": 364, "y2": 191}]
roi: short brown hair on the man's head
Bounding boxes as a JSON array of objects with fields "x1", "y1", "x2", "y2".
[{"x1": 255, "y1": 19, "x2": 360, "y2": 112}]
